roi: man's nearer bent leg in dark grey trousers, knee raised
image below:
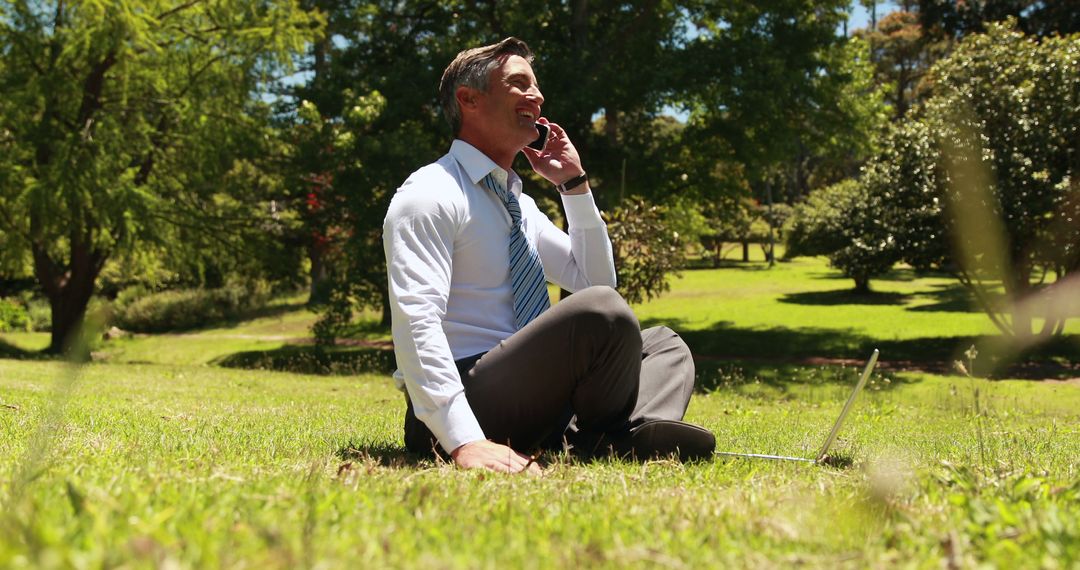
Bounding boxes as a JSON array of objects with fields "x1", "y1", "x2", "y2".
[{"x1": 462, "y1": 287, "x2": 642, "y2": 450}]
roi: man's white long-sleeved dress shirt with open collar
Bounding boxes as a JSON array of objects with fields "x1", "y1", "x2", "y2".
[{"x1": 382, "y1": 140, "x2": 616, "y2": 451}]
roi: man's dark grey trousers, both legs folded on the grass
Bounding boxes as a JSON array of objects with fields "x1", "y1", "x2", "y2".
[{"x1": 405, "y1": 287, "x2": 694, "y2": 453}]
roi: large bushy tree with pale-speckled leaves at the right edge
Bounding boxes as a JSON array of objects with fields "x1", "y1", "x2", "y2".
[{"x1": 923, "y1": 25, "x2": 1080, "y2": 339}]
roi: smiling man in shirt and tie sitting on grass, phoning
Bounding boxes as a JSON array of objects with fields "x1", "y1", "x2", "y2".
[{"x1": 383, "y1": 38, "x2": 715, "y2": 472}]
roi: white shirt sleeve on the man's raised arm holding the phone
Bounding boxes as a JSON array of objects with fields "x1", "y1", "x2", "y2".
[{"x1": 530, "y1": 192, "x2": 616, "y2": 293}]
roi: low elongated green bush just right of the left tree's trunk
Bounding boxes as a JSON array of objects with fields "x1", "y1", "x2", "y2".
[{"x1": 113, "y1": 282, "x2": 270, "y2": 333}]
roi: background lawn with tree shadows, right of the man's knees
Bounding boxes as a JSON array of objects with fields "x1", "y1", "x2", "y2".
[{"x1": 635, "y1": 258, "x2": 1080, "y2": 377}]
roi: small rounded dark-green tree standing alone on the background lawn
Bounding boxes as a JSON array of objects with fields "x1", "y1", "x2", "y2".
[{"x1": 786, "y1": 180, "x2": 899, "y2": 291}]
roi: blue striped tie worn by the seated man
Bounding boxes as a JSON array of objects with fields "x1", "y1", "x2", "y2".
[{"x1": 484, "y1": 174, "x2": 551, "y2": 329}]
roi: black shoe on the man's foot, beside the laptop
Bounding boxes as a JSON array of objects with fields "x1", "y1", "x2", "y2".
[{"x1": 582, "y1": 420, "x2": 716, "y2": 462}]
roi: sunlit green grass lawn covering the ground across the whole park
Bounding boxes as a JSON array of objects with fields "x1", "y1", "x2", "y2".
[{"x1": 0, "y1": 260, "x2": 1080, "y2": 568}]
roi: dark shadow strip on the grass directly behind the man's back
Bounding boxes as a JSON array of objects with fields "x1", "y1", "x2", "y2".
[{"x1": 211, "y1": 344, "x2": 394, "y2": 376}]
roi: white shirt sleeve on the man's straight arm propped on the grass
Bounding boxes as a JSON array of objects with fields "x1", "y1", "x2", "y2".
[{"x1": 382, "y1": 181, "x2": 485, "y2": 452}]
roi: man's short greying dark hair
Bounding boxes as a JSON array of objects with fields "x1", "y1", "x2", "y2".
[{"x1": 438, "y1": 38, "x2": 532, "y2": 135}]
